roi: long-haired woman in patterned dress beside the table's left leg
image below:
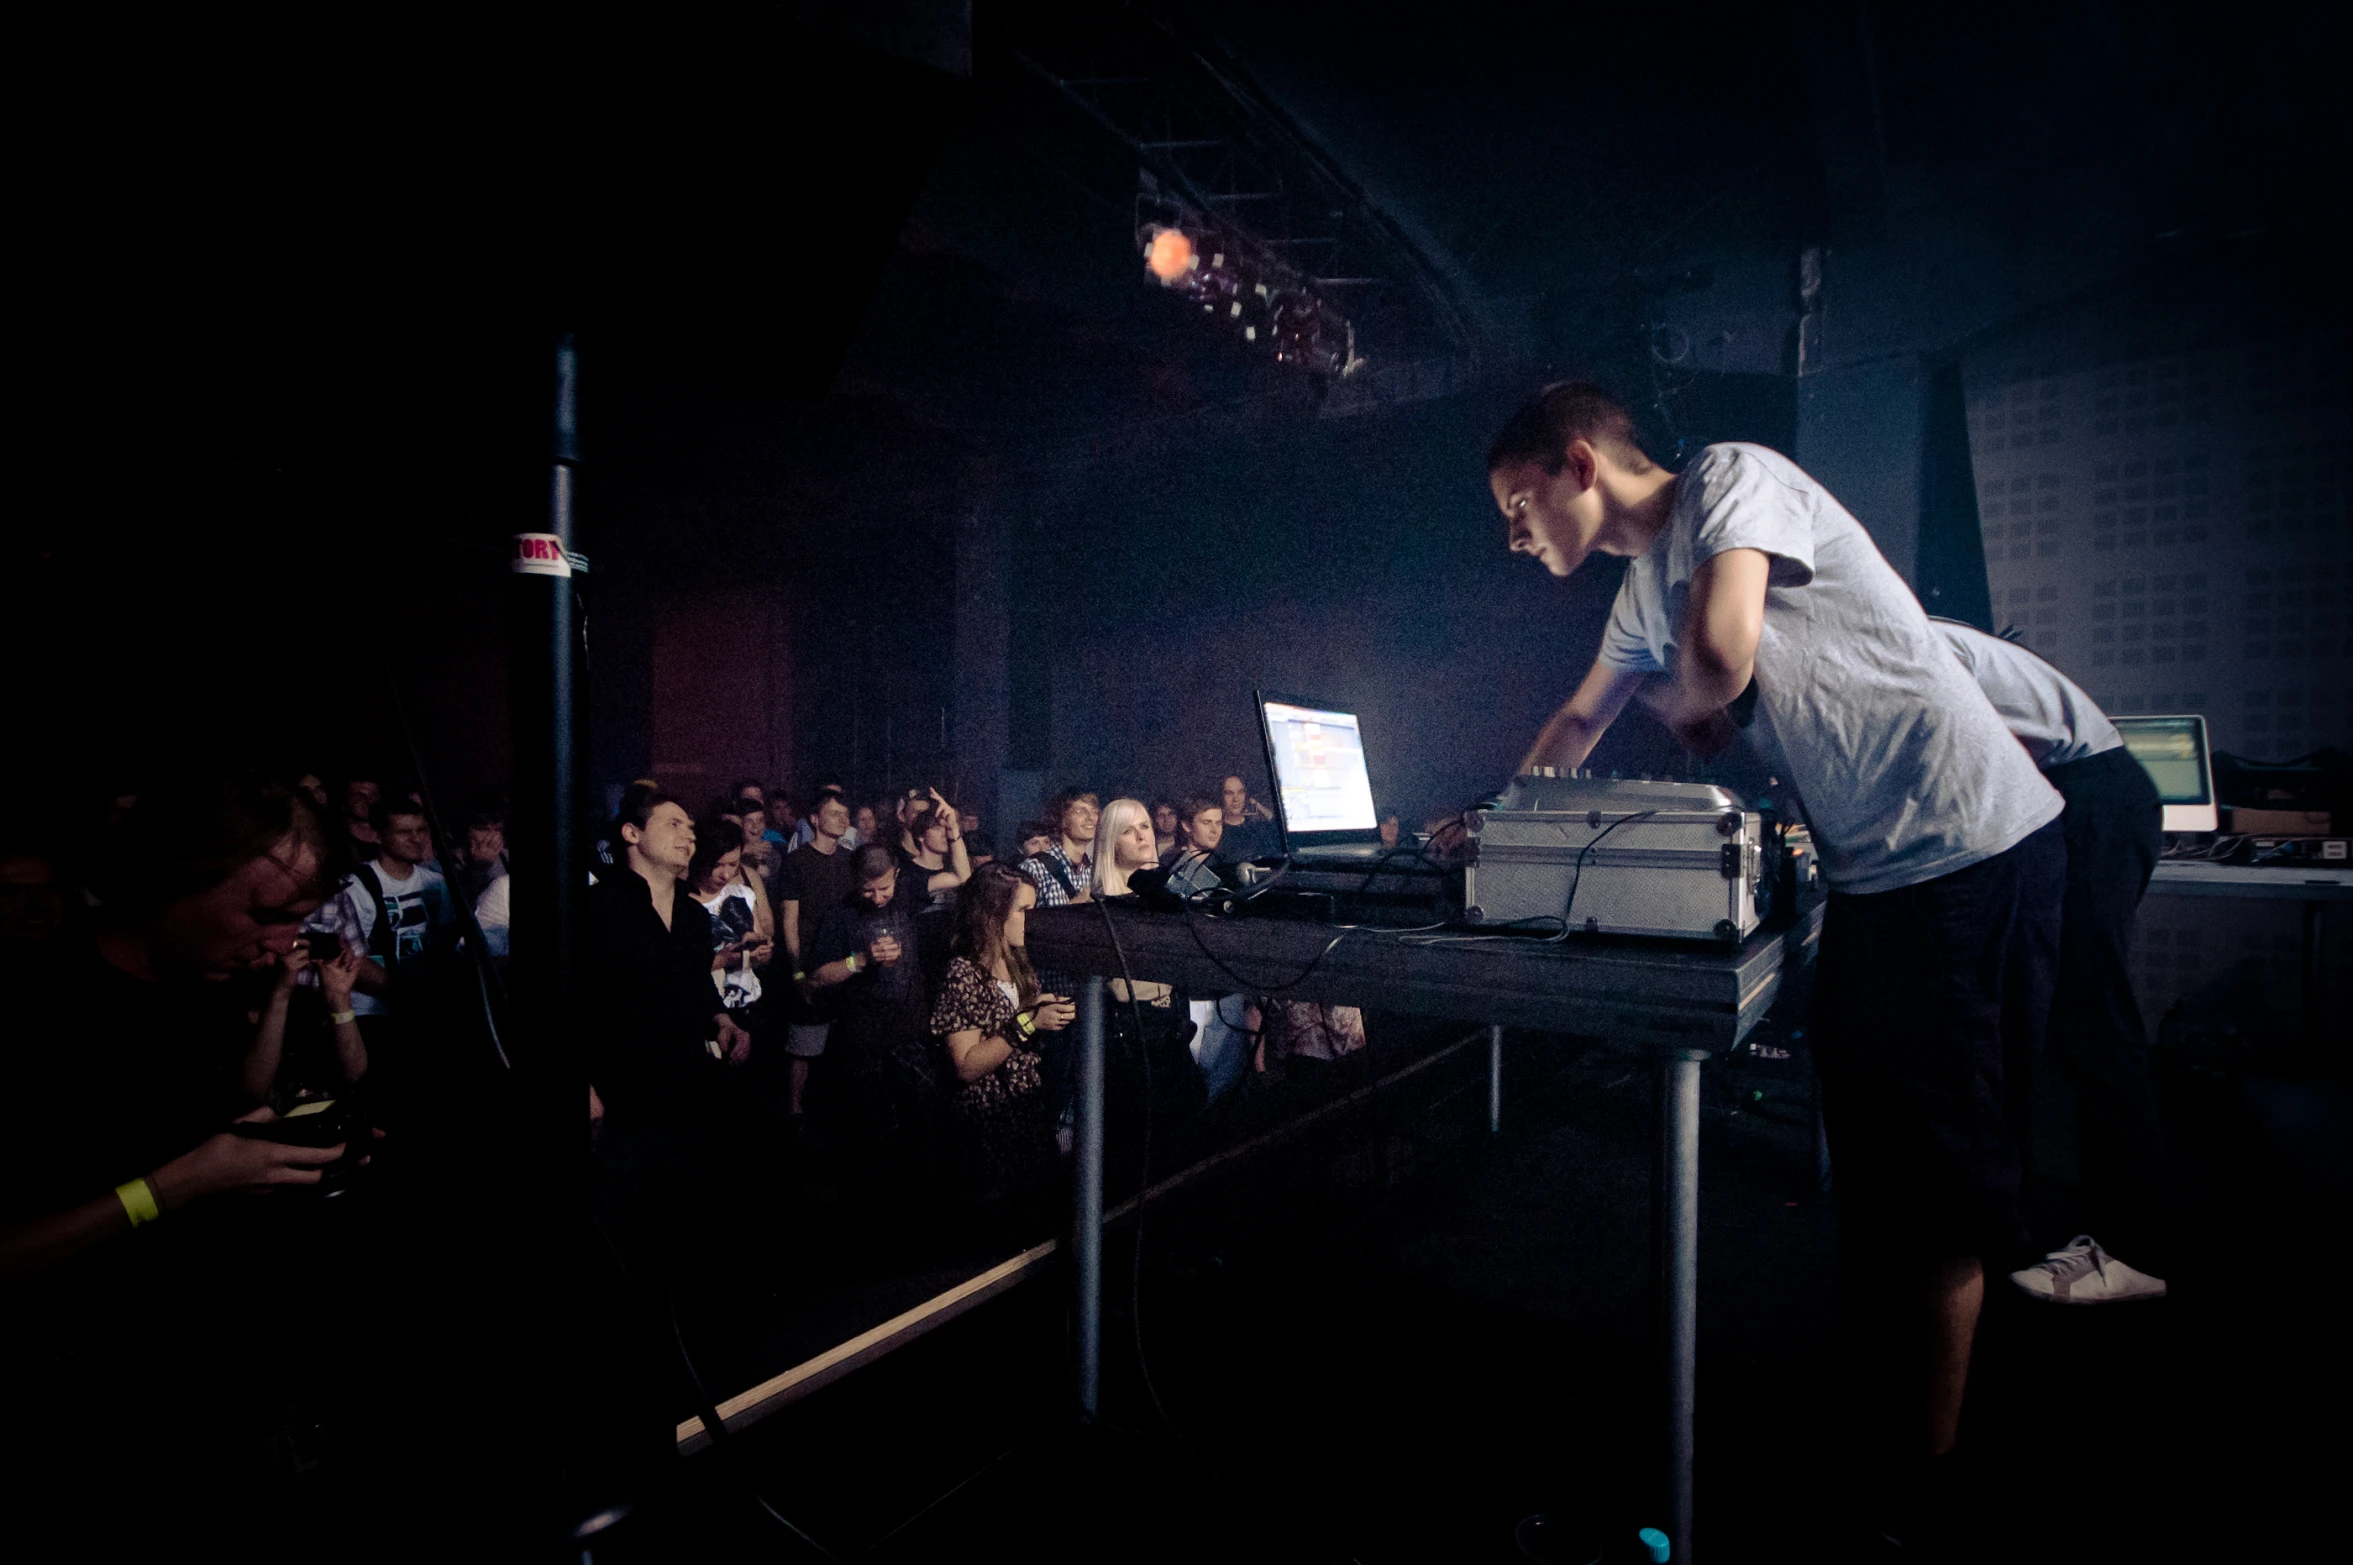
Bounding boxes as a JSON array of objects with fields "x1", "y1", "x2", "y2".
[{"x1": 932, "y1": 864, "x2": 1078, "y2": 1186}]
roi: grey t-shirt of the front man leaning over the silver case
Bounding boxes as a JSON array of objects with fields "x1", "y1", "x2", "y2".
[{"x1": 1600, "y1": 445, "x2": 2064, "y2": 894}]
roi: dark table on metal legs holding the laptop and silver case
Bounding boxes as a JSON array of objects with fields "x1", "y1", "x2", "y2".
[{"x1": 1028, "y1": 899, "x2": 1821, "y2": 1563}]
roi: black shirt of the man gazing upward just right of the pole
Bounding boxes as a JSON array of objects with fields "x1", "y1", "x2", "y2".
[{"x1": 584, "y1": 871, "x2": 727, "y2": 1127}]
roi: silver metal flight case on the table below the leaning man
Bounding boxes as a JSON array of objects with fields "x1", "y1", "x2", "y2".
[{"x1": 1464, "y1": 777, "x2": 1772, "y2": 944}]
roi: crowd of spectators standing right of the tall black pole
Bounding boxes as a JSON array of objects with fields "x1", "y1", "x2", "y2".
[{"x1": 571, "y1": 777, "x2": 1365, "y2": 1212}]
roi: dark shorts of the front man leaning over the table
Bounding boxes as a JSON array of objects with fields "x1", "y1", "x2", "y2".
[{"x1": 1814, "y1": 821, "x2": 2066, "y2": 1264}]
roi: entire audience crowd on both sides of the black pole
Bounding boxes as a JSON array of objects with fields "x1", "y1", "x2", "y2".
[{"x1": 0, "y1": 767, "x2": 1392, "y2": 1308}]
